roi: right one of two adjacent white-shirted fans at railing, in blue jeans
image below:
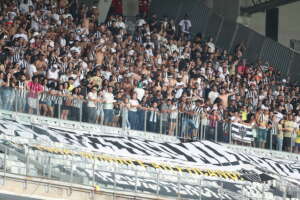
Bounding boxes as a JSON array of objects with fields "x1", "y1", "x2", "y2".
[{"x1": 103, "y1": 86, "x2": 116, "y2": 126}]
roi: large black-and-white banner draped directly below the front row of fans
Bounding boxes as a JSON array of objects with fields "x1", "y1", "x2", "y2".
[{"x1": 0, "y1": 119, "x2": 300, "y2": 182}]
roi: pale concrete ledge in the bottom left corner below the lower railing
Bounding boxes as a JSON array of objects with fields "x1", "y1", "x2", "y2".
[{"x1": 0, "y1": 172, "x2": 158, "y2": 200}]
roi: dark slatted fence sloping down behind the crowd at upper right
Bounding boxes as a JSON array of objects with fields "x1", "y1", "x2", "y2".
[{"x1": 151, "y1": 0, "x2": 300, "y2": 82}]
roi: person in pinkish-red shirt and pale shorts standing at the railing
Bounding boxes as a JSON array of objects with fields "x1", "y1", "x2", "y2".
[{"x1": 27, "y1": 76, "x2": 44, "y2": 114}]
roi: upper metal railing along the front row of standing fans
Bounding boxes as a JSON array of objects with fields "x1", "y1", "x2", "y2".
[{"x1": 0, "y1": 87, "x2": 295, "y2": 152}]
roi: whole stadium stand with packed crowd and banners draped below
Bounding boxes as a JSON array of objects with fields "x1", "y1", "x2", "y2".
[{"x1": 0, "y1": 0, "x2": 300, "y2": 199}]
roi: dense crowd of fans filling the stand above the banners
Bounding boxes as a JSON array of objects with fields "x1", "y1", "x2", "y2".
[{"x1": 0, "y1": 0, "x2": 300, "y2": 152}]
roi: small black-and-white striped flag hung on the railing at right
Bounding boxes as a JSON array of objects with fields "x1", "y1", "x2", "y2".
[{"x1": 231, "y1": 123, "x2": 254, "y2": 144}]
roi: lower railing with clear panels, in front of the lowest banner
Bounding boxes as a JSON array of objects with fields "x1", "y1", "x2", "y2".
[{"x1": 0, "y1": 141, "x2": 300, "y2": 199}]
